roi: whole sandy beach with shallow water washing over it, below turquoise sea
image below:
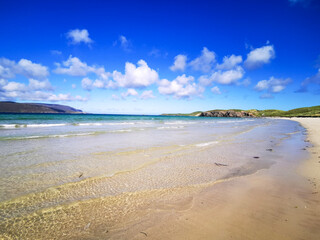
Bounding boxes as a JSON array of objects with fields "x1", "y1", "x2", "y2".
[{"x1": 0, "y1": 117, "x2": 320, "y2": 239}]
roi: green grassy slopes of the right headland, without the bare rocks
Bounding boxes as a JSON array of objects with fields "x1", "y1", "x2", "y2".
[{"x1": 163, "y1": 105, "x2": 320, "y2": 117}]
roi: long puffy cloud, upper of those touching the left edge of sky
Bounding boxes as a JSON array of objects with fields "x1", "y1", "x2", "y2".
[{"x1": 0, "y1": 58, "x2": 49, "y2": 79}]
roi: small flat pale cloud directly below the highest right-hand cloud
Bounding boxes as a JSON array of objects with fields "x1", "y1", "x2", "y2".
[{"x1": 254, "y1": 77, "x2": 291, "y2": 93}]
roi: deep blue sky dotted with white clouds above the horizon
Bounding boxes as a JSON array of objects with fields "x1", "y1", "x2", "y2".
[{"x1": 0, "y1": 0, "x2": 320, "y2": 114}]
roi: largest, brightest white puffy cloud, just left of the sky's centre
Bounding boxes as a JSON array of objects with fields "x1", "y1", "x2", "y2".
[{"x1": 110, "y1": 59, "x2": 159, "y2": 88}]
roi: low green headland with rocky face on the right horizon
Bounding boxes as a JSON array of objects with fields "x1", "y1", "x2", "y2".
[{"x1": 162, "y1": 106, "x2": 320, "y2": 117}]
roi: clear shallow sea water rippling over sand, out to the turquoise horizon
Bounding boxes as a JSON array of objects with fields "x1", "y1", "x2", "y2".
[{"x1": 0, "y1": 114, "x2": 304, "y2": 238}]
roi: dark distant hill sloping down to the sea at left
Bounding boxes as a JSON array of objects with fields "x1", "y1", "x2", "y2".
[{"x1": 0, "y1": 101, "x2": 83, "y2": 113}]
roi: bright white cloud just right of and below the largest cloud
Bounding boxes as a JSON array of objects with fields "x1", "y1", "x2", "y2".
[{"x1": 158, "y1": 74, "x2": 204, "y2": 98}]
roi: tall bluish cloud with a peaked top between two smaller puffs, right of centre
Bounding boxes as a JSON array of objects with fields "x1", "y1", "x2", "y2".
[{"x1": 189, "y1": 47, "x2": 216, "y2": 72}]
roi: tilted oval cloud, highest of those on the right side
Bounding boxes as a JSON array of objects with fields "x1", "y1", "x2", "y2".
[{"x1": 244, "y1": 45, "x2": 275, "y2": 69}]
